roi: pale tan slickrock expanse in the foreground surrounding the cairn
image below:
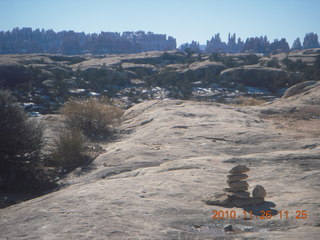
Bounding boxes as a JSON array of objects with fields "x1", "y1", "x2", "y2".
[{"x1": 0, "y1": 82, "x2": 320, "y2": 240}]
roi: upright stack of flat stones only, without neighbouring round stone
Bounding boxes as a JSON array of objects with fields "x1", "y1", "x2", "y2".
[{"x1": 223, "y1": 165, "x2": 250, "y2": 199}]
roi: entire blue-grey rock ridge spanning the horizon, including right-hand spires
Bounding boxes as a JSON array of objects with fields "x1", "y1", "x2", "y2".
[{"x1": 0, "y1": 28, "x2": 320, "y2": 55}]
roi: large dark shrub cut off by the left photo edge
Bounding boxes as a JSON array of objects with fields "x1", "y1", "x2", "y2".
[{"x1": 0, "y1": 90, "x2": 43, "y2": 187}]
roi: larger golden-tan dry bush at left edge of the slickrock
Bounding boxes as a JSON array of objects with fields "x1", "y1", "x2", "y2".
[{"x1": 62, "y1": 98, "x2": 123, "y2": 139}]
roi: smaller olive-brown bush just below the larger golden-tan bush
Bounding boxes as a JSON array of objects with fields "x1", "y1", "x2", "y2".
[{"x1": 51, "y1": 129, "x2": 88, "y2": 169}]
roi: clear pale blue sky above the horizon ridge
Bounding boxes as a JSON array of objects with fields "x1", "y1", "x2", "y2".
[{"x1": 0, "y1": 0, "x2": 320, "y2": 45}]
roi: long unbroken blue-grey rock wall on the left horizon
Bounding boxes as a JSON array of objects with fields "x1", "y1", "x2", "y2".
[{"x1": 0, "y1": 28, "x2": 176, "y2": 55}]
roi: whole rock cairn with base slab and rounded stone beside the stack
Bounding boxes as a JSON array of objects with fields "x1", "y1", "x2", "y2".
[{"x1": 203, "y1": 165, "x2": 266, "y2": 207}]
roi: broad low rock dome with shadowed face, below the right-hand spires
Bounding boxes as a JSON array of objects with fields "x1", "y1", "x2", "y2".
[{"x1": 220, "y1": 65, "x2": 287, "y2": 89}]
